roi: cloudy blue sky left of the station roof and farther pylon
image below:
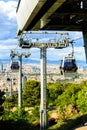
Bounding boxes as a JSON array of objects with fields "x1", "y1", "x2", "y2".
[{"x1": 0, "y1": 0, "x2": 17, "y2": 59}]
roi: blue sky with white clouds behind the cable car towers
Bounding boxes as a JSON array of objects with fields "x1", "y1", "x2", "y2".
[{"x1": 0, "y1": 0, "x2": 85, "y2": 66}]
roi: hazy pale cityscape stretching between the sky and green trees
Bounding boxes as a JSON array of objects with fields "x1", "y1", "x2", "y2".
[{"x1": 0, "y1": 61, "x2": 87, "y2": 96}]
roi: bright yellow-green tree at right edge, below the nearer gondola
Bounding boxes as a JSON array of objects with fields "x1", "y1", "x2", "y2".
[{"x1": 55, "y1": 81, "x2": 87, "y2": 112}]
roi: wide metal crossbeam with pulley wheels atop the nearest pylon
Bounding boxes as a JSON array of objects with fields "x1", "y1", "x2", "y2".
[{"x1": 18, "y1": 31, "x2": 70, "y2": 49}]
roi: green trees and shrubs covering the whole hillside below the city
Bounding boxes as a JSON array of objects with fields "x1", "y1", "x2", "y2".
[{"x1": 0, "y1": 80, "x2": 87, "y2": 130}]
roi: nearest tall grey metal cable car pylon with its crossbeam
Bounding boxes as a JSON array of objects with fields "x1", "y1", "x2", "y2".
[{"x1": 18, "y1": 31, "x2": 69, "y2": 130}]
